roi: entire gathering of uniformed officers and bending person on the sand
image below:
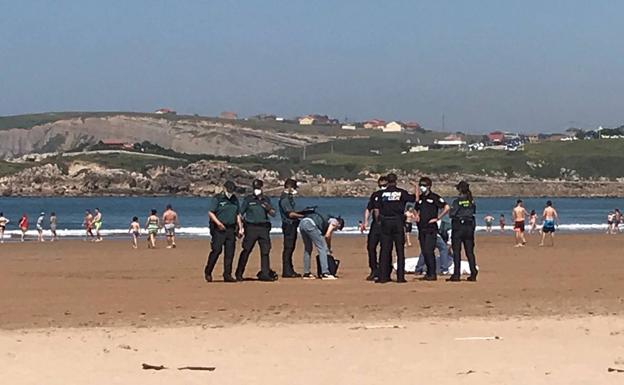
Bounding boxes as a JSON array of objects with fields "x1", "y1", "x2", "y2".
[{"x1": 204, "y1": 173, "x2": 478, "y2": 283}]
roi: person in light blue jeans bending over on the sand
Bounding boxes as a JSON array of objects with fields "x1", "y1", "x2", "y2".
[{"x1": 299, "y1": 211, "x2": 344, "y2": 281}]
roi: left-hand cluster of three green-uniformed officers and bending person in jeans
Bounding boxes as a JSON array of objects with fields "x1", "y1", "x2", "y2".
[{"x1": 204, "y1": 179, "x2": 344, "y2": 282}]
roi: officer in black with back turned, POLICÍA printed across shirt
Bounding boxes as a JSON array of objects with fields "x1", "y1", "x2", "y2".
[{"x1": 375, "y1": 174, "x2": 416, "y2": 283}]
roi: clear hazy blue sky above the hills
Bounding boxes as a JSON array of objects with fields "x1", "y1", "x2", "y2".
[{"x1": 0, "y1": 0, "x2": 624, "y2": 133}]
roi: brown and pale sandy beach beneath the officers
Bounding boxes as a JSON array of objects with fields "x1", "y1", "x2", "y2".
[{"x1": 0, "y1": 234, "x2": 624, "y2": 384}]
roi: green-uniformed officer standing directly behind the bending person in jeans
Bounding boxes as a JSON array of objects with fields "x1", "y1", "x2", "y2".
[{"x1": 279, "y1": 178, "x2": 303, "y2": 278}]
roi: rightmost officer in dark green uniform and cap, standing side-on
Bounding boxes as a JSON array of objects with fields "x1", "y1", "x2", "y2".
[{"x1": 447, "y1": 181, "x2": 479, "y2": 282}]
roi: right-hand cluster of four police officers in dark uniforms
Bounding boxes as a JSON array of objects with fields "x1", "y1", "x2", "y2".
[{"x1": 363, "y1": 173, "x2": 478, "y2": 283}]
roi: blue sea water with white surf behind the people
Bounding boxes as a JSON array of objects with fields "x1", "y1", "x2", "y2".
[{"x1": 0, "y1": 196, "x2": 624, "y2": 237}]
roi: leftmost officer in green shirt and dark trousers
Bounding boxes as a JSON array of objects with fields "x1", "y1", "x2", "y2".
[{"x1": 204, "y1": 180, "x2": 244, "y2": 282}]
